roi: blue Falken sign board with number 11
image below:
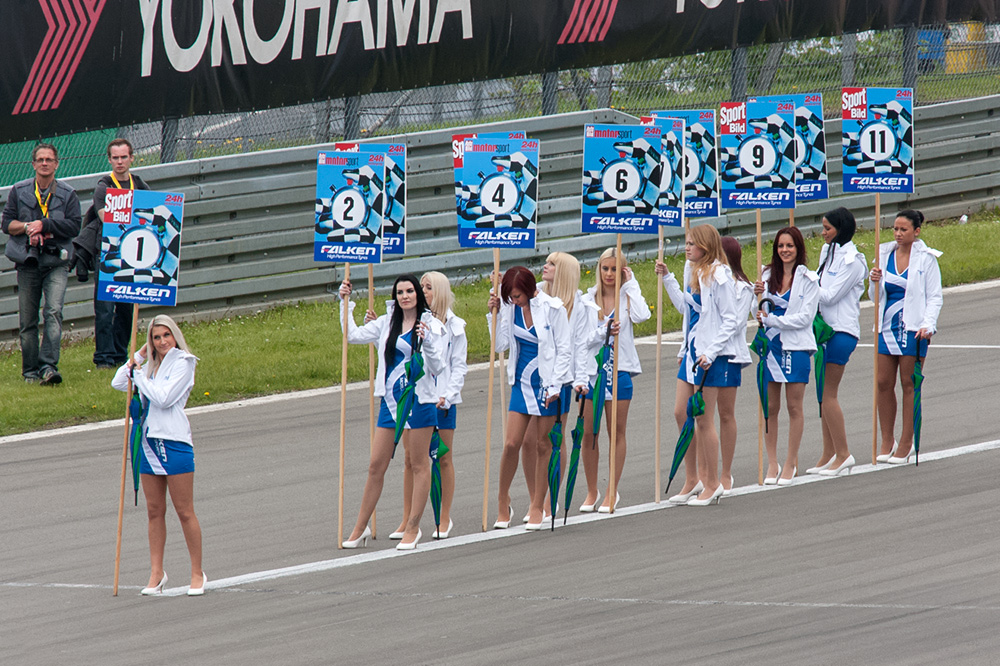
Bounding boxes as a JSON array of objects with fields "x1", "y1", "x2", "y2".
[{"x1": 841, "y1": 88, "x2": 915, "y2": 192}]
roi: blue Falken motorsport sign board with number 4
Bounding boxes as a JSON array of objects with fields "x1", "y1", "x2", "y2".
[{"x1": 455, "y1": 134, "x2": 538, "y2": 248}]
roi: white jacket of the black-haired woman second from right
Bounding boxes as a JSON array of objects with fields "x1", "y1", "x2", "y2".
[{"x1": 819, "y1": 241, "x2": 868, "y2": 338}]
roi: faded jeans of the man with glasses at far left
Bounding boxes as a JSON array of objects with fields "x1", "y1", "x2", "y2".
[{"x1": 17, "y1": 266, "x2": 69, "y2": 379}]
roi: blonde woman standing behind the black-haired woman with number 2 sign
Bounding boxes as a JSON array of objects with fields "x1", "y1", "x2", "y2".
[{"x1": 389, "y1": 271, "x2": 469, "y2": 539}]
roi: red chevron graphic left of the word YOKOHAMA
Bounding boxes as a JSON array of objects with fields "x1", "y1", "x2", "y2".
[{"x1": 12, "y1": 0, "x2": 106, "y2": 115}]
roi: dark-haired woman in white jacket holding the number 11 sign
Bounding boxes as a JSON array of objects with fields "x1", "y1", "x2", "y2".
[{"x1": 868, "y1": 210, "x2": 944, "y2": 465}]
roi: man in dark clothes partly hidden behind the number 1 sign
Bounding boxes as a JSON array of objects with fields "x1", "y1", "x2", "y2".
[{"x1": 72, "y1": 139, "x2": 149, "y2": 370}]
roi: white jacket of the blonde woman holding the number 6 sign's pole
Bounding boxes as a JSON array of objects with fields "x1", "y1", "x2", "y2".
[{"x1": 574, "y1": 276, "x2": 651, "y2": 384}]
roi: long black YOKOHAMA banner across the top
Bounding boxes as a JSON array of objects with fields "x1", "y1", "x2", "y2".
[{"x1": 0, "y1": 0, "x2": 1000, "y2": 142}]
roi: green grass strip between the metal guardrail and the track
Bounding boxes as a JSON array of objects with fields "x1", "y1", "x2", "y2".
[{"x1": 0, "y1": 211, "x2": 1000, "y2": 435}]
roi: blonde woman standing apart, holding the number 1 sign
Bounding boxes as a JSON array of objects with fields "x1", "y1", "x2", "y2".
[{"x1": 111, "y1": 315, "x2": 207, "y2": 596}]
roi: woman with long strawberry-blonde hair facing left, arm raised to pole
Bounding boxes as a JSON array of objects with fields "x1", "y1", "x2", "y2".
[{"x1": 656, "y1": 224, "x2": 746, "y2": 506}]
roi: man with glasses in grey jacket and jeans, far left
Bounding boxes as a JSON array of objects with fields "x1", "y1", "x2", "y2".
[{"x1": 0, "y1": 143, "x2": 81, "y2": 384}]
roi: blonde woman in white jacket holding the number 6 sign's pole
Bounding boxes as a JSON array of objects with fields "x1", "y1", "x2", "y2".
[{"x1": 576, "y1": 247, "x2": 650, "y2": 513}]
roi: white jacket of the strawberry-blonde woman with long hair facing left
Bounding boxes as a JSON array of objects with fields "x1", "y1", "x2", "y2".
[{"x1": 661, "y1": 261, "x2": 749, "y2": 363}]
